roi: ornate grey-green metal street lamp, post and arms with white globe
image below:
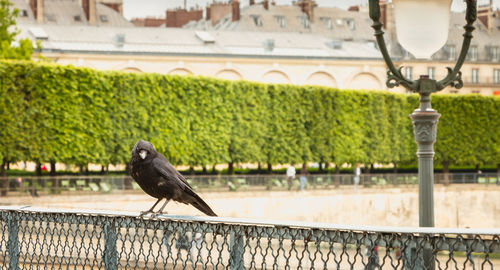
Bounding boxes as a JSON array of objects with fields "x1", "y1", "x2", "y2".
[{"x1": 369, "y1": 0, "x2": 477, "y2": 227}]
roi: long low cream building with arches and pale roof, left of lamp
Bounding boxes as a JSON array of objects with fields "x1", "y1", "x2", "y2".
[{"x1": 21, "y1": 25, "x2": 386, "y2": 89}]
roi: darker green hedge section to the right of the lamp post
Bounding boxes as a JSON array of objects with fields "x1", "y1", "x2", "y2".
[{"x1": 433, "y1": 95, "x2": 500, "y2": 165}]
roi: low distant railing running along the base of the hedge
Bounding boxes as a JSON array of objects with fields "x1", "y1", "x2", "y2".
[{"x1": 0, "y1": 173, "x2": 500, "y2": 196}]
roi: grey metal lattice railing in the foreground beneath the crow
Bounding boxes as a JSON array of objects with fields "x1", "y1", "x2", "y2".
[{"x1": 0, "y1": 207, "x2": 500, "y2": 270}]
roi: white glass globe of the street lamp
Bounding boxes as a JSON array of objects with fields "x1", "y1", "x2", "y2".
[{"x1": 392, "y1": 0, "x2": 452, "y2": 59}]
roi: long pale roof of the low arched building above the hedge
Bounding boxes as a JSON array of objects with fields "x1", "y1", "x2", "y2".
[{"x1": 19, "y1": 24, "x2": 380, "y2": 59}]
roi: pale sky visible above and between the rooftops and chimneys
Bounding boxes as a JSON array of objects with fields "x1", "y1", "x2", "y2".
[{"x1": 123, "y1": 0, "x2": 500, "y2": 19}]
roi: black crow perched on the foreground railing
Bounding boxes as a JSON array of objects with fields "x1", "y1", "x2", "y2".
[{"x1": 130, "y1": 140, "x2": 217, "y2": 216}]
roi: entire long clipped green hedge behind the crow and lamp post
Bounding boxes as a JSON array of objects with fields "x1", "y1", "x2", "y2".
[{"x1": 0, "y1": 61, "x2": 500, "y2": 170}]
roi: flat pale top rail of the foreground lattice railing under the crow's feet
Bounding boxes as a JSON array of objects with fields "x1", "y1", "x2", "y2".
[{"x1": 0, "y1": 205, "x2": 500, "y2": 236}]
